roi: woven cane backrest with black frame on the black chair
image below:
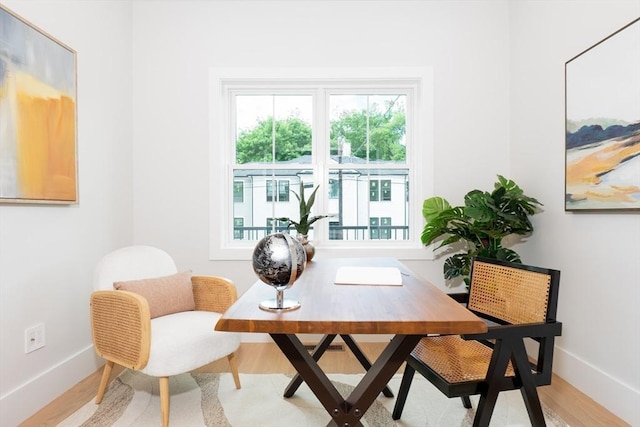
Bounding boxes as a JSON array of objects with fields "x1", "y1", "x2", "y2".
[{"x1": 468, "y1": 257, "x2": 560, "y2": 324}]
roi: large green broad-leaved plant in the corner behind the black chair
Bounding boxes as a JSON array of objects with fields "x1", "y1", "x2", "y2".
[{"x1": 421, "y1": 175, "x2": 542, "y2": 288}]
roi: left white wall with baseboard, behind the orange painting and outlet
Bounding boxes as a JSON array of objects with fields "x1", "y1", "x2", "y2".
[{"x1": 0, "y1": 0, "x2": 133, "y2": 426}]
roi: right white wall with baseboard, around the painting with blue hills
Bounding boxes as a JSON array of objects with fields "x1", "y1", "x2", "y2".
[{"x1": 510, "y1": 0, "x2": 640, "y2": 426}]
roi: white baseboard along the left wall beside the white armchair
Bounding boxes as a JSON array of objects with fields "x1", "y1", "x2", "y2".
[{"x1": 0, "y1": 345, "x2": 104, "y2": 426}]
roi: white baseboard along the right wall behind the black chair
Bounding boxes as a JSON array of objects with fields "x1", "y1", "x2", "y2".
[{"x1": 553, "y1": 346, "x2": 640, "y2": 426}]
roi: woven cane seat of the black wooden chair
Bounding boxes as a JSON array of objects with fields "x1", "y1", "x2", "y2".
[{"x1": 411, "y1": 335, "x2": 515, "y2": 383}]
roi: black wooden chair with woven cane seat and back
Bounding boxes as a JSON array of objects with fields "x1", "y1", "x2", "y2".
[{"x1": 393, "y1": 258, "x2": 562, "y2": 426}]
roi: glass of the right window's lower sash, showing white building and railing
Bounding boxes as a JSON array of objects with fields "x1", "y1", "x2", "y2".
[{"x1": 329, "y1": 169, "x2": 409, "y2": 240}]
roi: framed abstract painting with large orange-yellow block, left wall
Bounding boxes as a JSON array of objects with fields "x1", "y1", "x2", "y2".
[{"x1": 0, "y1": 5, "x2": 78, "y2": 204}]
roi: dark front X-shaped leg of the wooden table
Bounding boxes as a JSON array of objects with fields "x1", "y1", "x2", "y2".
[{"x1": 270, "y1": 334, "x2": 423, "y2": 427}]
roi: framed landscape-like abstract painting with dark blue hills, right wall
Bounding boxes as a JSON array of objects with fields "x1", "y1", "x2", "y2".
[{"x1": 565, "y1": 18, "x2": 640, "y2": 211}]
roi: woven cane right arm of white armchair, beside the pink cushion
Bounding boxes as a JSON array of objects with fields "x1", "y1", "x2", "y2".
[{"x1": 191, "y1": 276, "x2": 238, "y2": 313}]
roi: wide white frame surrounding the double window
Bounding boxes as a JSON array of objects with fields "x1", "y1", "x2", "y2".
[{"x1": 209, "y1": 67, "x2": 433, "y2": 260}]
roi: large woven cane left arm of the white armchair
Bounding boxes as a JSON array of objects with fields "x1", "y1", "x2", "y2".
[{"x1": 91, "y1": 290, "x2": 151, "y2": 370}]
